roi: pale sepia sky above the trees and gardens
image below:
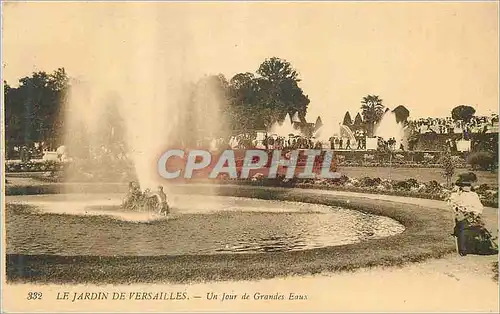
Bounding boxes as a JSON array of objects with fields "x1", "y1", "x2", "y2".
[{"x1": 2, "y1": 1, "x2": 499, "y2": 122}]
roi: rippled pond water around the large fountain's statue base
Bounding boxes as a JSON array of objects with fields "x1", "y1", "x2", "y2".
[{"x1": 6, "y1": 195, "x2": 404, "y2": 256}]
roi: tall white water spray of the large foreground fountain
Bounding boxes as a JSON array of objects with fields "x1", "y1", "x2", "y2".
[{"x1": 61, "y1": 3, "x2": 230, "y2": 199}]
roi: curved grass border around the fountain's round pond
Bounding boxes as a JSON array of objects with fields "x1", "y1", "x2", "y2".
[{"x1": 6, "y1": 186, "x2": 455, "y2": 284}]
